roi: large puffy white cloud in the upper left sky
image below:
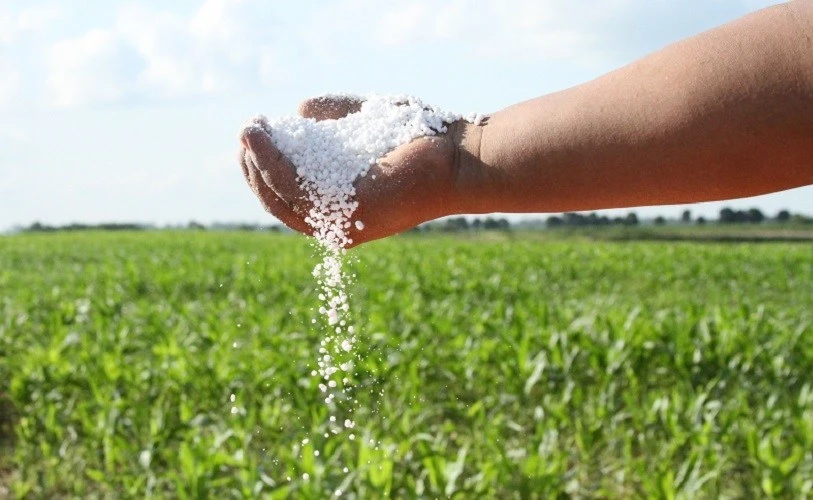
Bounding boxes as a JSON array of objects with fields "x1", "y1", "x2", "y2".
[{"x1": 48, "y1": 0, "x2": 286, "y2": 106}]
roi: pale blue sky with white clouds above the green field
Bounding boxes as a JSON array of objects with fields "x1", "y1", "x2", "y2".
[{"x1": 0, "y1": 0, "x2": 813, "y2": 230}]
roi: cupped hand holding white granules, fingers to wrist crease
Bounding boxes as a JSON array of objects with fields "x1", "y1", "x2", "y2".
[{"x1": 239, "y1": 96, "x2": 468, "y2": 246}]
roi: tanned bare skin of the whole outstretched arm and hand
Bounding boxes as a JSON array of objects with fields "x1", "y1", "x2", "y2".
[{"x1": 240, "y1": 0, "x2": 813, "y2": 245}]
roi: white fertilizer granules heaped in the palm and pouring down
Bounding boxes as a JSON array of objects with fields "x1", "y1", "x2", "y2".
[{"x1": 241, "y1": 95, "x2": 482, "y2": 439}]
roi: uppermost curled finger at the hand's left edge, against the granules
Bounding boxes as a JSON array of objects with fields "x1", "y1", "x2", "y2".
[{"x1": 242, "y1": 127, "x2": 310, "y2": 217}]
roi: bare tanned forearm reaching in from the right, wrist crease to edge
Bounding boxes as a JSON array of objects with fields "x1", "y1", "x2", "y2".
[{"x1": 457, "y1": 1, "x2": 813, "y2": 213}]
